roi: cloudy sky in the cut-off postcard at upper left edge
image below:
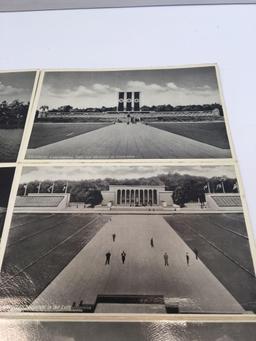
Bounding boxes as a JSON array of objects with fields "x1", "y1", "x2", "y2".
[{"x1": 0, "y1": 72, "x2": 36, "y2": 103}]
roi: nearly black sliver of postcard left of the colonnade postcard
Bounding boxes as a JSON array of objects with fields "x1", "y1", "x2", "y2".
[{"x1": 0, "y1": 167, "x2": 15, "y2": 240}]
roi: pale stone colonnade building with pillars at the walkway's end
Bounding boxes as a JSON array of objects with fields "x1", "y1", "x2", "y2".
[{"x1": 101, "y1": 185, "x2": 173, "y2": 206}]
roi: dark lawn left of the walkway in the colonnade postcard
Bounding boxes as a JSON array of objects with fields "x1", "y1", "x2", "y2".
[{"x1": 0, "y1": 213, "x2": 107, "y2": 308}]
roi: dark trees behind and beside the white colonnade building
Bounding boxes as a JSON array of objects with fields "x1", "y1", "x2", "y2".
[{"x1": 18, "y1": 173, "x2": 238, "y2": 206}]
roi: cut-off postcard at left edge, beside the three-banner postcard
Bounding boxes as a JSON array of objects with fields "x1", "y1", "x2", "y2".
[{"x1": 0, "y1": 71, "x2": 36, "y2": 162}]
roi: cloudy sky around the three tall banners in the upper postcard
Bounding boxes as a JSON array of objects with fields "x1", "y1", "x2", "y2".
[{"x1": 38, "y1": 67, "x2": 220, "y2": 108}]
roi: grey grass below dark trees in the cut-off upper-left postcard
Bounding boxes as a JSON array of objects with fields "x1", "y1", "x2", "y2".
[{"x1": 0, "y1": 129, "x2": 23, "y2": 162}]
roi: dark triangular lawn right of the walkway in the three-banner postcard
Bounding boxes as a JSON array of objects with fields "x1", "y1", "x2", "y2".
[{"x1": 148, "y1": 122, "x2": 230, "y2": 149}]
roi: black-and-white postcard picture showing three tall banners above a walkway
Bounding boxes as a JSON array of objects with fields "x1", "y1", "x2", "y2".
[{"x1": 26, "y1": 65, "x2": 231, "y2": 160}]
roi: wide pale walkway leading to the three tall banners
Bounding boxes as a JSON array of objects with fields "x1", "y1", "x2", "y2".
[{"x1": 27, "y1": 123, "x2": 230, "y2": 159}]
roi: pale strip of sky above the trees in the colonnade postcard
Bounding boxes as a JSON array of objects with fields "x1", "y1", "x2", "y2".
[{"x1": 20, "y1": 166, "x2": 235, "y2": 183}]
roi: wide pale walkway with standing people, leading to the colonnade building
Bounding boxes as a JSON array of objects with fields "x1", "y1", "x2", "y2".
[{"x1": 30, "y1": 215, "x2": 243, "y2": 313}]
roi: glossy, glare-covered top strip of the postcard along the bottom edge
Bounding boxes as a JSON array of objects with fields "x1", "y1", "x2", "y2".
[{"x1": 0, "y1": 319, "x2": 256, "y2": 341}]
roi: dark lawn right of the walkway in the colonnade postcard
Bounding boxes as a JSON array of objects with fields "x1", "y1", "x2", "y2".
[{"x1": 165, "y1": 213, "x2": 256, "y2": 312}]
